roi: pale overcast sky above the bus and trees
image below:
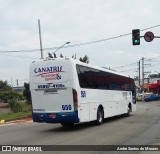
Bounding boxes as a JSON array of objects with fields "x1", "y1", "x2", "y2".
[{"x1": 0, "y1": 0, "x2": 160, "y2": 86}]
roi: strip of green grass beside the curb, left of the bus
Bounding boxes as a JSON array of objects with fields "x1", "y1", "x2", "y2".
[{"x1": 0, "y1": 111, "x2": 32, "y2": 121}]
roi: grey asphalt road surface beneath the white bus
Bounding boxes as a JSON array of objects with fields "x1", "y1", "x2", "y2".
[{"x1": 0, "y1": 101, "x2": 160, "y2": 153}]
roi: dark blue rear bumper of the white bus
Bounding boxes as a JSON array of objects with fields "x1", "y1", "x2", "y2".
[{"x1": 32, "y1": 111, "x2": 79, "y2": 123}]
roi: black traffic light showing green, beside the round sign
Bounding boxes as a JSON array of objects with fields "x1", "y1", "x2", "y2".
[{"x1": 132, "y1": 29, "x2": 140, "y2": 45}]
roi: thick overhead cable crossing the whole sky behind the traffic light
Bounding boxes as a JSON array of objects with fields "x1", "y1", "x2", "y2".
[{"x1": 0, "y1": 25, "x2": 160, "y2": 53}]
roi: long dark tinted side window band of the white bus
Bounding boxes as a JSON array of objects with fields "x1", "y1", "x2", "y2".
[{"x1": 76, "y1": 65, "x2": 134, "y2": 91}]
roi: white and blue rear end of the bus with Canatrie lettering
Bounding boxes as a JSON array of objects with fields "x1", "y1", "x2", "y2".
[{"x1": 30, "y1": 59, "x2": 79, "y2": 123}]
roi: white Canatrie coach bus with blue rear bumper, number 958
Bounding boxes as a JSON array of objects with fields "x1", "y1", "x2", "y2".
[{"x1": 30, "y1": 58, "x2": 136, "y2": 126}]
